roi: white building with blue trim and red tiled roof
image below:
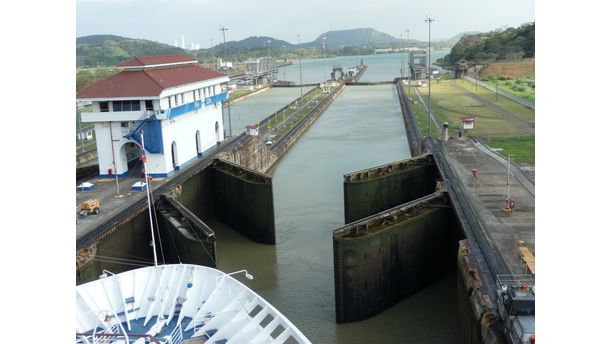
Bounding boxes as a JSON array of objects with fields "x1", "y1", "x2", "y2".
[{"x1": 77, "y1": 55, "x2": 229, "y2": 177}]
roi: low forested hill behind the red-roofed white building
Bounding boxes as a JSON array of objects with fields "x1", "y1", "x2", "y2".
[{"x1": 76, "y1": 35, "x2": 186, "y2": 67}]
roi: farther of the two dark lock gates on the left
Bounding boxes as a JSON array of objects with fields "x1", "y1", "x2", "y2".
[{"x1": 209, "y1": 161, "x2": 276, "y2": 244}]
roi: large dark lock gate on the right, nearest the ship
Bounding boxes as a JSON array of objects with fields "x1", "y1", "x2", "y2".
[{"x1": 334, "y1": 208, "x2": 457, "y2": 323}]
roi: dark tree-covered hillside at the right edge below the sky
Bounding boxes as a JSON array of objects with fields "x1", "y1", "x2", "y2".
[{"x1": 444, "y1": 22, "x2": 535, "y2": 64}]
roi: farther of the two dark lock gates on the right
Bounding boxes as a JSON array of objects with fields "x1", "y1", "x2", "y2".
[{"x1": 344, "y1": 156, "x2": 439, "y2": 224}]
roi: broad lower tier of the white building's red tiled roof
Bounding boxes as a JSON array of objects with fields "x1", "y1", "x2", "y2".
[{"x1": 77, "y1": 65, "x2": 225, "y2": 99}]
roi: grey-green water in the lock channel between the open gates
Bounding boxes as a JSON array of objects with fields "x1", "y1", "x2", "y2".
[{"x1": 213, "y1": 85, "x2": 458, "y2": 343}]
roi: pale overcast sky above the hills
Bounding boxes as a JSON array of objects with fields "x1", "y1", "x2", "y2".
[{"x1": 76, "y1": 0, "x2": 535, "y2": 48}]
